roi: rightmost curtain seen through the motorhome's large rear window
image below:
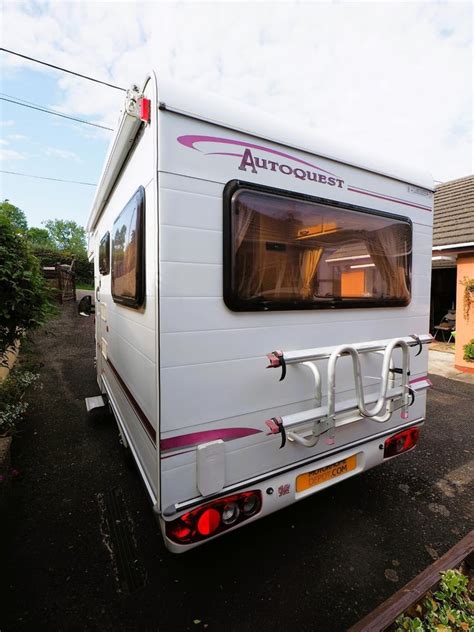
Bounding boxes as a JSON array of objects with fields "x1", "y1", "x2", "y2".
[{"x1": 365, "y1": 224, "x2": 410, "y2": 300}]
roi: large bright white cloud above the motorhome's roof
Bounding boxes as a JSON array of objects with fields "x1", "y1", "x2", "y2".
[{"x1": 3, "y1": 2, "x2": 473, "y2": 180}]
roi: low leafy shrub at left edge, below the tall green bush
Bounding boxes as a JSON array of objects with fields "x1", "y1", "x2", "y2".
[{"x1": 0, "y1": 368, "x2": 39, "y2": 436}]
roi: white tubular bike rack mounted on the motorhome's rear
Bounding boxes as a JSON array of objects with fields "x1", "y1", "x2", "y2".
[{"x1": 265, "y1": 334, "x2": 433, "y2": 447}]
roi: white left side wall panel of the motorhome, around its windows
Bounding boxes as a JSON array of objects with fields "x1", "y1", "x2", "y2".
[{"x1": 93, "y1": 81, "x2": 159, "y2": 502}]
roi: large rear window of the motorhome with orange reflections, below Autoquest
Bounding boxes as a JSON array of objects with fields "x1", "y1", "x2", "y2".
[{"x1": 224, "y1": 183, "x2": 412, "y2": 311}]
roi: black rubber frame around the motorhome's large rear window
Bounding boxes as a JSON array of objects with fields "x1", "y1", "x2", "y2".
[{"x1": 223, "y1": 179, "x2": 413, "y2": 312}]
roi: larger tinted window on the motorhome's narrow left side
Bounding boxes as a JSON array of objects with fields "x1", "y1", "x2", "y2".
[{"x1": 112, "y1": 187, "x2": 145, "y2": 307}]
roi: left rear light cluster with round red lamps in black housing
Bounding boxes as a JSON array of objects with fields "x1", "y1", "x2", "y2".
[{"x1": 166, "y1": 490, "x2": 262, "y2": 544}]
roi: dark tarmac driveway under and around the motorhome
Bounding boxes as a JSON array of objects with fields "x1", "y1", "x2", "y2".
[{"x1": 0, "y1": 305, "x2": 474, "y2": 632}]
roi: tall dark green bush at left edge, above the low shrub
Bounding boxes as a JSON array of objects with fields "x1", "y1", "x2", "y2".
[{"x1": 0, "y1": 213, "x2": 50, "y2": 361}]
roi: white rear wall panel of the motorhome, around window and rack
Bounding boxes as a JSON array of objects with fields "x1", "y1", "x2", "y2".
[{"x1": 159, "y1": 111, "x2": 432, "y2": 507}]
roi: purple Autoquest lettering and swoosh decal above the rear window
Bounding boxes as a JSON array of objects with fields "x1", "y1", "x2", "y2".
[{"x1": 177, "y1": 134, "x2": 344, "y2": 189}]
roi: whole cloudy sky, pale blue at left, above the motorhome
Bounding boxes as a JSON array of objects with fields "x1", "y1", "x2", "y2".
[{"x1": 0, "y1": 0, "x2": 474, "y2": 226}]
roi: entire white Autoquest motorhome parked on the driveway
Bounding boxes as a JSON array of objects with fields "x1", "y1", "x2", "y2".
[{"x1": 88, "y1": 74, "x2": 433, "y2": 552}]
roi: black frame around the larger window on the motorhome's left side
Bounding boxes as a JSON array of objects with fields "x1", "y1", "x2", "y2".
[{"x1": 110, "y1": 185, "x2": 145, "y2": 309}]
